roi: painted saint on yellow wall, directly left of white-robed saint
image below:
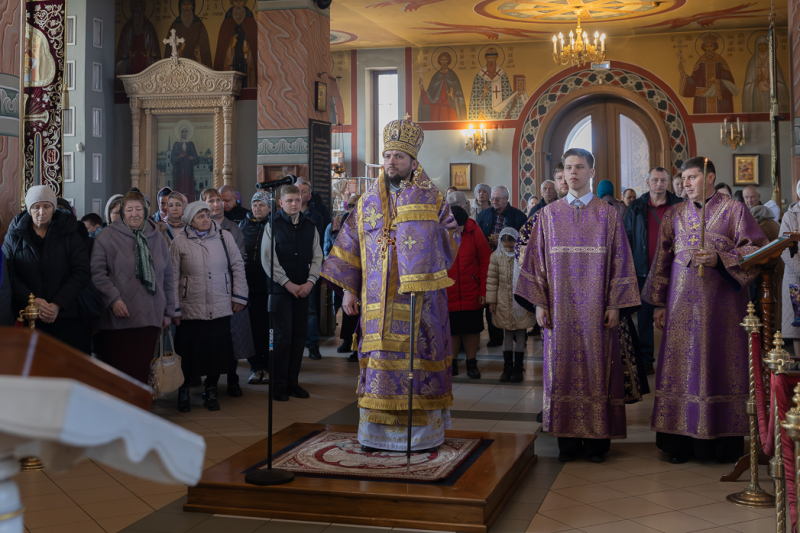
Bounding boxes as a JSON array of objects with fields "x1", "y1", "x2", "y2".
[{"x1": 417, "y1": 52, "x2": 467, "y2": 122}]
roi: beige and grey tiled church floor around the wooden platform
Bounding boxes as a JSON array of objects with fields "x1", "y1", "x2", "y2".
[{"x1": 17, "y1": 326, "x2": 775, "y2": 533}]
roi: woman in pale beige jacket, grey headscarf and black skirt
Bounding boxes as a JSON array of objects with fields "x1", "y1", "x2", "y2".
[{"x1": 170, "y1": 202, "x2": 248, "y2": 412}]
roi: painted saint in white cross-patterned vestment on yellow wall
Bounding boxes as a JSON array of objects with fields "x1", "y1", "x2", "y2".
[{"x1": 468, "y1": 46, "x2": 514, "y2": 120}]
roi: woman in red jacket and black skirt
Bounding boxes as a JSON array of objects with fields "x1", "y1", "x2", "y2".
[{"x1": 447, "y1": 206, "x2": 492, "y2": 379}]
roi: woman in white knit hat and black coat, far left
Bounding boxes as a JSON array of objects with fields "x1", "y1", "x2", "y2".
[{"x1": 3, "y1": 185, "x2": 92, "y2": 354}]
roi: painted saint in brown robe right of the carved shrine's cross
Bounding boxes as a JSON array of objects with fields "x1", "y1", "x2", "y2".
[{"x1": 214, "y1": 0, "x2": 258, "y2": 87}]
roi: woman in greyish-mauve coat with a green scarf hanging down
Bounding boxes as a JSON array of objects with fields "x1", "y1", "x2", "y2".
[{"x1": 92, "y1": 191, "x2": 176, "y2": 383}]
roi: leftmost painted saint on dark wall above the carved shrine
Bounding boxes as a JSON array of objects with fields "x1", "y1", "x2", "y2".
[{"x1": 114, "y1": 0, "x2": 161, "y2": 91}]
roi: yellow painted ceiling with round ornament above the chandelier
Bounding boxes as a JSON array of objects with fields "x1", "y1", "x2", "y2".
[{"x1": 331, "y1": 0, "x2": 788, "y2": 50}]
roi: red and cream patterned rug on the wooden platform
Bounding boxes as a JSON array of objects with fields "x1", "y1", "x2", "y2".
[{"x1": 262, "y1": 431, "x2": 481, "y2": 482}]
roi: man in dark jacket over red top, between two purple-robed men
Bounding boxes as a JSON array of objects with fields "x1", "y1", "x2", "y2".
[{"x1": 623, "y1": 167, "x2": 682, "y2": 374}]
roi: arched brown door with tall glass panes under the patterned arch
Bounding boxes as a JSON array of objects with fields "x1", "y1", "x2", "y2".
[{"x1": 548, "y1": 98, "x2": 664, "y2": 198}]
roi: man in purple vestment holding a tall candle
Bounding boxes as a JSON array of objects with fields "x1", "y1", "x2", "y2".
[{"x1": 642, "y1": 157, "x2": 767, "y2": 464}]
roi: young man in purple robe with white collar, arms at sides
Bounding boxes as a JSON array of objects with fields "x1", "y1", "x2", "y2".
[{"x1": 515, "y1": 148, "x2": 641, "y2": 463}]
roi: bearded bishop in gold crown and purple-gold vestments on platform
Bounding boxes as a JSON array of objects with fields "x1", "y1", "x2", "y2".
[{"x1": 322, "y1": 115, "x2": 461, "y2": 451}]
